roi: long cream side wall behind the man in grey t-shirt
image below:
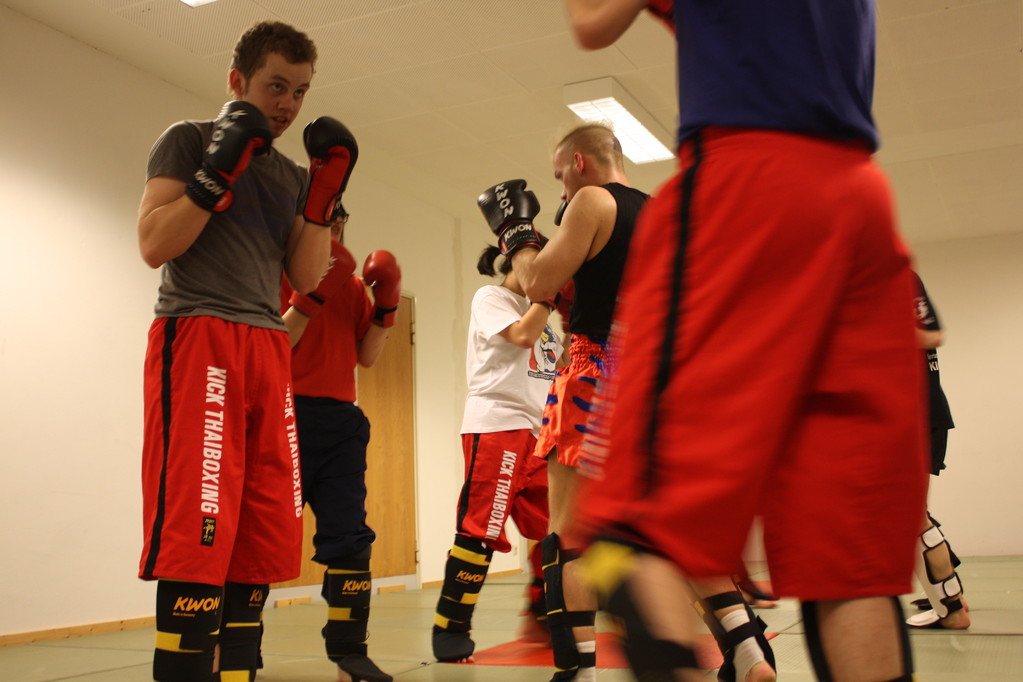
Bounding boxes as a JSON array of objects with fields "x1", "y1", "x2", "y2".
[{"x1": 0, "y1": 7, "x2": 478, "y2": 635}]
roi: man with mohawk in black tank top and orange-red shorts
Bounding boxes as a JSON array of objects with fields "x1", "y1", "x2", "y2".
[{"x1": 480, "y1": 125, "x2": 647, "y2": 681}]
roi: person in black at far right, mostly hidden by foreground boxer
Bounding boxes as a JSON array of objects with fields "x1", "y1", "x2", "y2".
[{"x1": 906, "y1": 275, "x2": 970, "y2": 630}]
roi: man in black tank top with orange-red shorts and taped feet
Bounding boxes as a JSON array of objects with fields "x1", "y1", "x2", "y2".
[{"x1": 481, "y1": 125, "x2": 773, "y2": 682}]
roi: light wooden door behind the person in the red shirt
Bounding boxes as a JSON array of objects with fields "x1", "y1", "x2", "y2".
[{"x1": 273, "y1": 295, "x2": 416, "y2": 587}]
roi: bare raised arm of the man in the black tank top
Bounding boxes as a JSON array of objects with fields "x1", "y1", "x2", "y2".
[{"x1": 512, "y1": 186, "x2": 618, "y2": 301}]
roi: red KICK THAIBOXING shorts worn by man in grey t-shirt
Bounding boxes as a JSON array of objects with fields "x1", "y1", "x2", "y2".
[{"x1": 139, "y1": 317, "x2": 302, "y2": 585}]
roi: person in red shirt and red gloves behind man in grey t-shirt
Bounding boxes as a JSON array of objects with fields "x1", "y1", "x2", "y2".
[{"x1": 282, "y1": 141, "x2": 401, "y2": 682}]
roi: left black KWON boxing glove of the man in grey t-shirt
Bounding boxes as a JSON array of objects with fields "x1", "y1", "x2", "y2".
[{"x1": 185, "y1": 100, "x2": 273, "y2": 213}]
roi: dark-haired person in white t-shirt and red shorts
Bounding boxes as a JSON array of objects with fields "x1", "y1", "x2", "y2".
[{"x1": 433, "y1": 242, "x2": 563, "y2": 662}]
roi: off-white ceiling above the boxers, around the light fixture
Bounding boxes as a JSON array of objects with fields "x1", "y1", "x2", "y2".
[{"x1": 0, "y1": 0, "x2": 1023, "y2": 241}]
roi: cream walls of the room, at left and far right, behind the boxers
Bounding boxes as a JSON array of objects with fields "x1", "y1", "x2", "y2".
[{"x1": 0, "y1": 7, "x2": 1023, "y2": 635}]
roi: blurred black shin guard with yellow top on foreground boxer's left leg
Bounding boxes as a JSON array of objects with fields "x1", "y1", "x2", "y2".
[{"x1": 585, "y1": 540, "x2": 700, "y2": 682}]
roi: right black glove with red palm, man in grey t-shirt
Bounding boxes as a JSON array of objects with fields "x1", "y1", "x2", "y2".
[{"x1": 302, "y1": 116, "x2": 359, "y2": 225}]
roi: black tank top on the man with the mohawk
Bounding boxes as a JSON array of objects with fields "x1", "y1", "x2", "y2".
[{"x1": 569, "y1": 182, "x2": 650, "y2": 336}]
